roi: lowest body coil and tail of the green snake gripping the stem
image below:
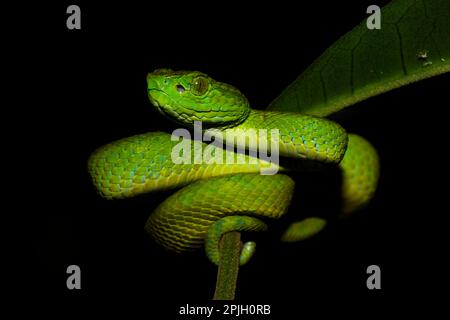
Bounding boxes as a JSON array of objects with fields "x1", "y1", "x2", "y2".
[{"x1": 145, "y1": 173, "x2": 294, "y2": 263}]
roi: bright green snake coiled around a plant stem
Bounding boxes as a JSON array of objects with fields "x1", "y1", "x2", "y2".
[{"x1": 88, "y1": 69, "x2": 379, "y2": 264}]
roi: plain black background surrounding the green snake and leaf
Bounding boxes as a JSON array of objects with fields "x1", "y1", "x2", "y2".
[{"x1": 20, "y1": 1, "x2": 450, "y2": 318}]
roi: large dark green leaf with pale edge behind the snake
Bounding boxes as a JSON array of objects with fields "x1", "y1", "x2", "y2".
[{"x1": 269, "y1": 0, "x2": 450, "y2": 116}]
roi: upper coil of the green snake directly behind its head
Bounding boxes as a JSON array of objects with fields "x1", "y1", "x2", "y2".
[{"x1": 205, "y1": 110, "x2": 348, "y2": 164}]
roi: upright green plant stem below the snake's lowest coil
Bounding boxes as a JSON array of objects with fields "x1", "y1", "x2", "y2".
[{"x1": 213, "y1": 231, "x2": 242, "y2": 300}]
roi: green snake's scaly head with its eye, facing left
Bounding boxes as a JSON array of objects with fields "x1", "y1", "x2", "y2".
[{"x1": 147, "y1": 69, "x2": 250, "y2": 127}]
